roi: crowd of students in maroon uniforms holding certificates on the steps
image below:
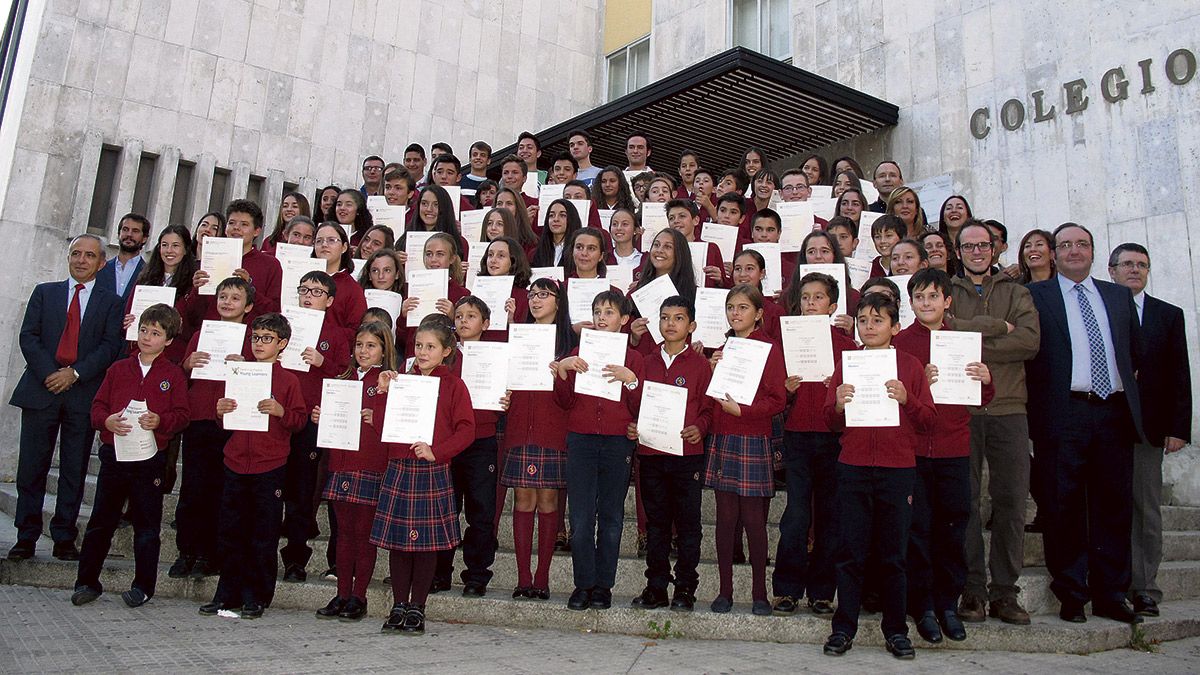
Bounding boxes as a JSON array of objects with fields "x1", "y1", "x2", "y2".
[{"x1": 46, "y1": 135, "x2": 1142, "y2": 658}]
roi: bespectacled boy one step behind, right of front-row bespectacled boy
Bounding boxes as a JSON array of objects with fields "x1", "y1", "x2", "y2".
[{"x1": 280, "y1": 271, "x2": 350, "y2": 583}]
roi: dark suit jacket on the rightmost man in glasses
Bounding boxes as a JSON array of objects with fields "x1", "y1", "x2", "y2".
[{"x1": 1138, "y1": 295, "x2": 1192, "y2": 448}]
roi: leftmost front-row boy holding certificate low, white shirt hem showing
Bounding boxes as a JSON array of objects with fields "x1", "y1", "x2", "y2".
[{"x1": 71, "y1": 304, "x2": 187, "y2": 607}]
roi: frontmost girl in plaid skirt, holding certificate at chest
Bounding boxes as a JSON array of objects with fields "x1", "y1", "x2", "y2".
[{"x1": 371, "y1": 316, "x2": 475, "y2": 635}]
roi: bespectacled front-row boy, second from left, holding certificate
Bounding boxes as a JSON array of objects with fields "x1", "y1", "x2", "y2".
[{"x1": 200, "y1": 312, "x2": 307, "y2": 619}]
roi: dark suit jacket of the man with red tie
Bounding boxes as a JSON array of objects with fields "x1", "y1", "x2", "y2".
[{"x1": 8, "y1": 281, "x2": 126, "y2": 413}]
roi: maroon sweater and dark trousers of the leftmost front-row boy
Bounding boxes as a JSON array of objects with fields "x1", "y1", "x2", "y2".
[{"x1": 76, "y1": 354, "x2": 188, "y2": 598}]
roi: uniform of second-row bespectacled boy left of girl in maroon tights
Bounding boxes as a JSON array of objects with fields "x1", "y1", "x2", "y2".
[{"x1": 280, "y1": 317, "x2": 350, "y2": 569}]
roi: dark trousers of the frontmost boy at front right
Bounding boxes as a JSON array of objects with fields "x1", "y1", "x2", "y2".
[{"x1": 833, "y1": 462, "x2": 916, "y2": 638}]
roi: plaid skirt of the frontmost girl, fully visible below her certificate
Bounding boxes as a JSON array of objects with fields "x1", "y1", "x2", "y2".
[{"x1": 371, "y1": 459, "x2": 461, "y2": 552}]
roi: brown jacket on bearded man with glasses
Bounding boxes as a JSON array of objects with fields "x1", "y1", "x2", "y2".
[{"x1": 946, "y1": 274, "x2": 1042, "y2": 416}]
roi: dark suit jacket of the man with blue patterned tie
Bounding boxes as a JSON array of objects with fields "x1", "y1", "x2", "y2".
[{"x1": 1025, "y1": 277, "x2": 1145, "y2": 443}]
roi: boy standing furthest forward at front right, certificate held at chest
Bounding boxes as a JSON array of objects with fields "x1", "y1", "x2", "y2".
[{"x1": 823, "y1": 293, "x2": 936, "y2": 659}]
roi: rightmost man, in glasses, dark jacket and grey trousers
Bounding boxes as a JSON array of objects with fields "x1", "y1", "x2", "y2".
[{"x1": 1109, "y1": 244, "x2": 1192, "y2": 616}]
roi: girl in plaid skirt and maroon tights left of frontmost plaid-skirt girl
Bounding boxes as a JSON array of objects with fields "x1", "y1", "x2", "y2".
[{"x1": 311, "y1": 322, "x2": 396, "y2": 621}]
